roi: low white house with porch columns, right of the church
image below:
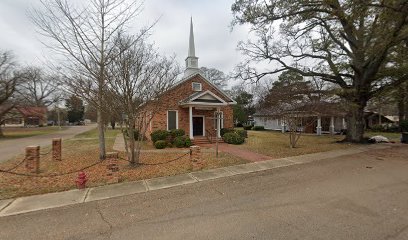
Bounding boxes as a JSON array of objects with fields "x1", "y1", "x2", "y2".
[{"x1": 253, "y1": 102, "x2": 346, "y2": 135}]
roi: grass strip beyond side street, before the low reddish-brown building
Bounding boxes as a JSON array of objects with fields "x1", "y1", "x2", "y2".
[{"x1": 0, "y1": 126, "x2": 66, "y2": 141}]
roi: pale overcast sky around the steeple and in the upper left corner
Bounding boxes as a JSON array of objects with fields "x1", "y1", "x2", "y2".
[{"x1": 0, "y1": 0, "x2": 253, "y2": 77}]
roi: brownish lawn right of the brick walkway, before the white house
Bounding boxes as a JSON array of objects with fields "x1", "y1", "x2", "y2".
[{"x1": 241, "y1": 131, "x2": 352, "y2": 158}]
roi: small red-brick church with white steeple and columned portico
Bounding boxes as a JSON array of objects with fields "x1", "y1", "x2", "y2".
[{"x1": 144, "y1": 19, "x2": 236, "y2": 140}]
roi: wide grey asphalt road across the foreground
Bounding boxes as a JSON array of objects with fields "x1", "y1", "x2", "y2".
[{"x1": 0, "y1": 145, "x2": 408, "y2": 240}]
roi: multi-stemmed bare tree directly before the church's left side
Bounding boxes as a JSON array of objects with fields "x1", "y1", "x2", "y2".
[{"x1": 108, "y1": 36, "x2": 180, "y2": 165}]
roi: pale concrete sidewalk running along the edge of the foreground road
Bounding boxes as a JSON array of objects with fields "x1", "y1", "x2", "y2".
[{"x1": 0, "y1": 144, "x2": 391, "y2": 217}]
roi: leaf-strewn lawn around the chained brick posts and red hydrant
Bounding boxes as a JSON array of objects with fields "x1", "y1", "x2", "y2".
[{"x1": 0, "y1": 130, "x2": 247, "y2": 199}]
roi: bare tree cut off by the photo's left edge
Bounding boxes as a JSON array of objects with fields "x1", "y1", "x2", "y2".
[{"x1": 0, "y1": 50, "x2": 22, "y2": 136}]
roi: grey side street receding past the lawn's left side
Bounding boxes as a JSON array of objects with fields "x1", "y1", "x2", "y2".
[{"x1": 0, "y1": 124, "x2": 96, "y2": 163}]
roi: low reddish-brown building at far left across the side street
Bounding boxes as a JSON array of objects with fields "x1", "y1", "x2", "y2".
[{"x1": 2, "y1": 106, "x2": 47, "y2": 127}]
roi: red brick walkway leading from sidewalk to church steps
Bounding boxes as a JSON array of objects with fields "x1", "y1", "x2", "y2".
[{"x1": 199, "y1": 143, "x2": 272, "y2": 162}]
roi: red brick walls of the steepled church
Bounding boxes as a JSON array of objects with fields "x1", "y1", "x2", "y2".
[{"x1": 146, "y1": 75, "x2": 233, "y2": 138}]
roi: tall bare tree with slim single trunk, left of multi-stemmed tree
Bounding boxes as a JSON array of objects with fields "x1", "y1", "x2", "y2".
[{"x1": 31, "y1": 0, "x2": 149, "y2": 160}]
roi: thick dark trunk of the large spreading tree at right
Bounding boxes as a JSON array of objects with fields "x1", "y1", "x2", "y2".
[{"x1": 345, "y1": 100, "x2": 367, "y2": 143}]
